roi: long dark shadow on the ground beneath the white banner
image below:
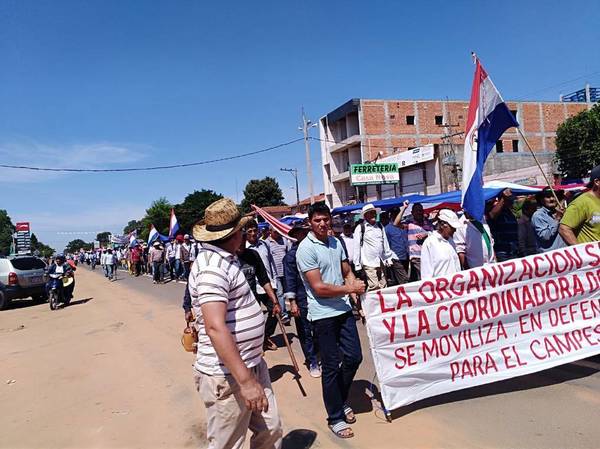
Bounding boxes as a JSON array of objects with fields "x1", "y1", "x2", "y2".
[{"x1": 391, "y1": 356, "x2": 600, "y2": 419}]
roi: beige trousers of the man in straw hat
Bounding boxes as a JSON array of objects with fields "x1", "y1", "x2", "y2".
[{"x1": 194, "y1": 360, "x2": 283, "y2": 449}]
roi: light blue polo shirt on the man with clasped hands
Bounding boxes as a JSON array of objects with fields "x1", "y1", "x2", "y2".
[{"x1": 296, "y1": 232, "x2": 352, "y2": 321}]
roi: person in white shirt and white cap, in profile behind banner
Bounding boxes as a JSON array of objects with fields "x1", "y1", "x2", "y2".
[{"x1": 421, "y1": 209, "x2": 462, "y2": 279}]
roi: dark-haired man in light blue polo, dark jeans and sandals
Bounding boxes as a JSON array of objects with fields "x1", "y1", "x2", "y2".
[{"x1": 296, "y1": 203, "x2": 366, "y2": 438}]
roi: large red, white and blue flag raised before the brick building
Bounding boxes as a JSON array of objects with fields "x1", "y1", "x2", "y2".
[{"x1": 461, "y1": 54, "x2": 519, "y2": 222}]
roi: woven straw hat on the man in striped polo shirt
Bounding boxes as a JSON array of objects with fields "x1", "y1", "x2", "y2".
[{"x1": 192, "y1": 198, "x2": 252, "y2": 242}]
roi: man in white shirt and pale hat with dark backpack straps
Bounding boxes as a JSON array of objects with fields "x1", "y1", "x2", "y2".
[{"x1": 354, "y1": 204, "x2": 398, "y2": 291}]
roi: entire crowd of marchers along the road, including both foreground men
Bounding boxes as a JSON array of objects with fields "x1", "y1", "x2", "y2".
[{"x1": 63, "y1": 167, "x2": 600, "y2": 448}]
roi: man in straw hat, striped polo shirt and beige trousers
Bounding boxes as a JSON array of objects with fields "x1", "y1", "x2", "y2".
[{"x1": 188, "y1": 198, "x2": 283, "y2": 449}]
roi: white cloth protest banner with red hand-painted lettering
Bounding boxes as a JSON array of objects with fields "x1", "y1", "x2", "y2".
[{"x1": 363, "y1": 242, "x2": 600, "y2": 409}]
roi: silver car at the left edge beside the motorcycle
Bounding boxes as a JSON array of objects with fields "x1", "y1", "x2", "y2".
[{"x1": 0, "y1": 256, "x2": 47, "y2": 310}]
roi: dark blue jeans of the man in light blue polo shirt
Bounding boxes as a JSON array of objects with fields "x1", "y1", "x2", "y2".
[{"x1": 313, "y1": 312, "x2": 362, "y2": 425}]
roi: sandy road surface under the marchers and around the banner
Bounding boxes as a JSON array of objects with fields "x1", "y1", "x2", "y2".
[{"x1": 0, "y1": 268, "x2": 600, "y2": 449}]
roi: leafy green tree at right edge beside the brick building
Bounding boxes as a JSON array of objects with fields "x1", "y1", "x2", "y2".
[{"x1": 556, "y1": 105, "x2": 600, "y2": 178}]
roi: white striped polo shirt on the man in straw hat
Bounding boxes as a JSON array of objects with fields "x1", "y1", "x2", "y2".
[{"x1": 188, "y1": 243, "x2": 265, "y2": 376}]
